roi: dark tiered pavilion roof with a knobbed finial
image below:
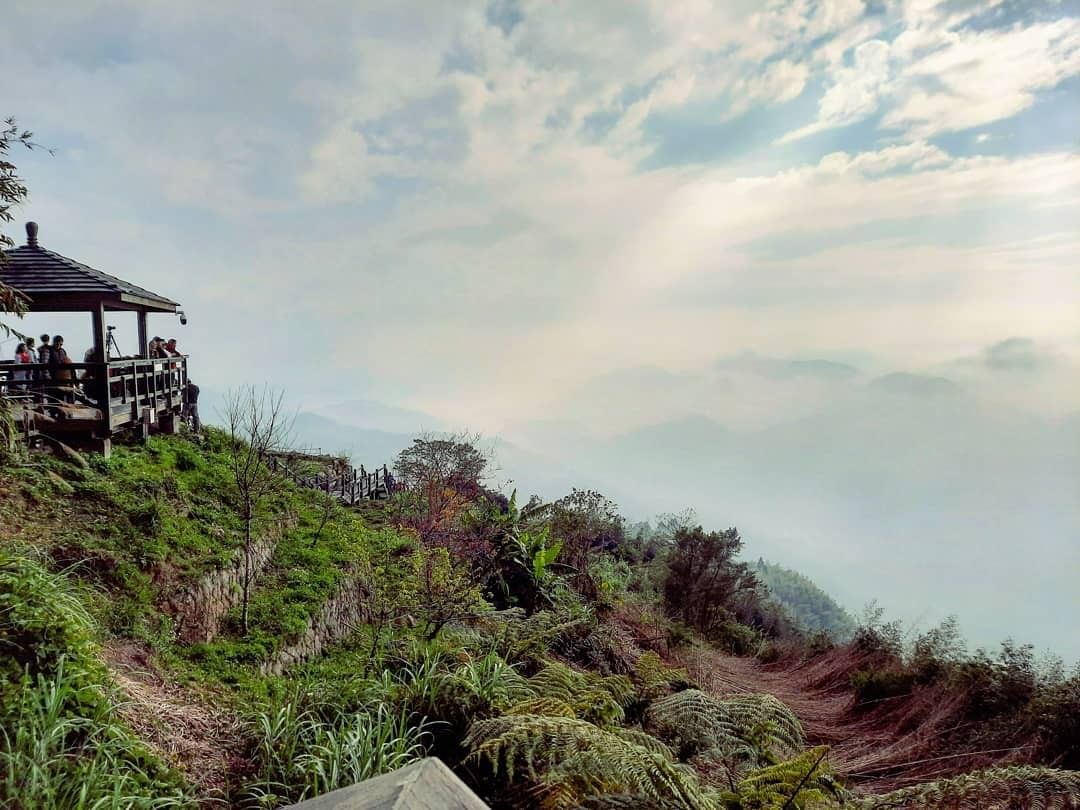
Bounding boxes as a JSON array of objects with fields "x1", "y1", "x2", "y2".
[{"x1": 0, "y1": 222, "x2": 179, "y2": 312}]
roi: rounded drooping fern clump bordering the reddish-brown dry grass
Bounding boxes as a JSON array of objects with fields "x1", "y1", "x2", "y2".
[{"x1": 645, "y1": 689, "x2": 804, "y2": 783}]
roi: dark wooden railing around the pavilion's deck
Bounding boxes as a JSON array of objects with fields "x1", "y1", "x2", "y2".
[{"x1": 0, "y1": 356, "x2": 188, "y2": 433}]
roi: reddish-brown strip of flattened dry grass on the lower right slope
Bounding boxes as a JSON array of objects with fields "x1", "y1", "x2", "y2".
[{"x1": 678, "y1": 649, "x2": 986, "y2": 793}]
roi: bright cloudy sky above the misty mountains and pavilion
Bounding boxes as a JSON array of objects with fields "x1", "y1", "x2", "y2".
[{"x1": 0, "y1": 0, "x2": 1080, "y2": 652}]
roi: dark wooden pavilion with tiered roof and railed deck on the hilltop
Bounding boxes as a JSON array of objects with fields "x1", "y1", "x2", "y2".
[{"x1": 0, "y1": 222, "x2": 188, "y2": 454}]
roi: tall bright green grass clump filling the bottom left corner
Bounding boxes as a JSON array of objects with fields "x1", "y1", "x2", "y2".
[{"x1": 0, "y1": 553, "x2": 192, "y2": 810}]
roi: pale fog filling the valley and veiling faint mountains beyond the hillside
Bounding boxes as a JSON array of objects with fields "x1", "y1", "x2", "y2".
[{"x1": 272, "y1": 338, "x2": 1080, "y2": 660}]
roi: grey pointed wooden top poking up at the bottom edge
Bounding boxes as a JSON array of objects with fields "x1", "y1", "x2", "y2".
[{"x1": 289, "y1": 757, "x2": 490, "y2": 810}]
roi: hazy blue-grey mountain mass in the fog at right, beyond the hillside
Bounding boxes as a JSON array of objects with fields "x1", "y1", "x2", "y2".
[{"x1": 557, "y1": 384, "x2": 1080, "y2": 657}]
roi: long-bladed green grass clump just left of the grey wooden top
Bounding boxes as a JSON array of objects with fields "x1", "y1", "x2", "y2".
[{"x1": 241, "y1": 696, "x2": 426, "y2": 807}]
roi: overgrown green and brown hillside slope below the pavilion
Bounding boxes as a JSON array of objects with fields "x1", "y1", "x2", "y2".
[{"x1": 0, "y1": 431, "x2": 1080, "y2": 810}]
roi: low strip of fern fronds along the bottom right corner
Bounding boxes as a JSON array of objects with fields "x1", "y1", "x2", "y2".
[{"x1": 855, "y1": 766, "x2": 1080, "y2": 810}]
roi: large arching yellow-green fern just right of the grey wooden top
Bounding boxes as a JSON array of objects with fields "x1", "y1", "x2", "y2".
[{"x1": 464, "y1": 715, "x2": 713, "y2": 810}]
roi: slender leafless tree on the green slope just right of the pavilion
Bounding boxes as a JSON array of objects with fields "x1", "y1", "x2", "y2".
[{"x1": 225, "y1": 386, "x2": 293, "y2": 633}]
